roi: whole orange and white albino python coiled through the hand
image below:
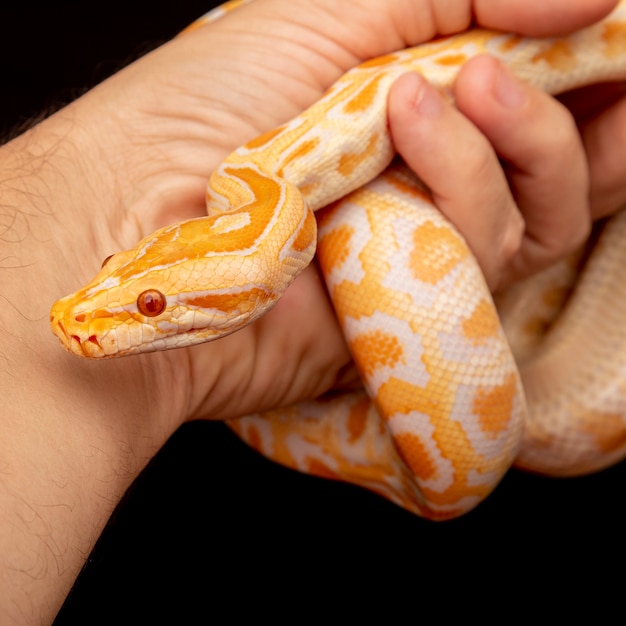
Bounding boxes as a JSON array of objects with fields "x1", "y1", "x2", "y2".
[{"x1": 51, "y1": 0, "x2": 626, "y2": 519}]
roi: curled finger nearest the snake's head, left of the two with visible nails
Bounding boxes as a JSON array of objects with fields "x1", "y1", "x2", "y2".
[{"x1": 389, "y1": 67, "x2": 523, "y2": 286}]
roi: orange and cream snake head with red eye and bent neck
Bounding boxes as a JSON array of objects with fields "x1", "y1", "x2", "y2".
[{"x1": 50, "y1": 166, "x2": 317, "y2": 358}]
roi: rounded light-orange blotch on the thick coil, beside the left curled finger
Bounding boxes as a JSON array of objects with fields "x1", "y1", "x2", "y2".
[{"x1": 410, "y1": 222, "x2": 468, "y2": 285}]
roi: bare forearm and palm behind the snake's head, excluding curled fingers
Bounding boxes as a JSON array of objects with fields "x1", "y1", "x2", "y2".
[{"x1": 0, "y1": 0, "x2": 611, "y2": 619}]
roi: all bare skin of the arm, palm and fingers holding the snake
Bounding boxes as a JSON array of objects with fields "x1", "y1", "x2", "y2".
[{"x1": 0, "y1": 0, "x2": 626, "y2": 624}]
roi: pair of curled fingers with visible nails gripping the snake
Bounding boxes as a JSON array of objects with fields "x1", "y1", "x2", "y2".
[{"x1": 389, "y1": 57, "x2": 590, "y2": 289}]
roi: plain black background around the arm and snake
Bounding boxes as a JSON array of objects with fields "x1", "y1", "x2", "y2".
[{"x1": 0, "y1": 1, "x2": 626, "y2": 626}]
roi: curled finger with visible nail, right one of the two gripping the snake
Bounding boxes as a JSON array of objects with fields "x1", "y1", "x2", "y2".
[{"x1": 455, "y1": 56, "x2": 591, "y2": 277}]
